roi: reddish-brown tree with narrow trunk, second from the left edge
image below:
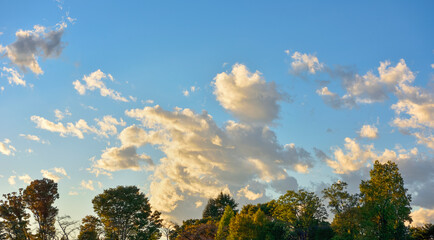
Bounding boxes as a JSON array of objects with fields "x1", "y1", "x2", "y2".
[{"x1": 23, "y1": 178, "x2": 59, "y2": 240}]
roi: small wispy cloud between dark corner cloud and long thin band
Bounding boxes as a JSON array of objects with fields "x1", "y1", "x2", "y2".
[{"x1": 72, "y1": 69, "x2": 128, "y2": 102}]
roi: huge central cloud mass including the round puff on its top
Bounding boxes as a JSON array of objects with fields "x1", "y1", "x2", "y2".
[{"x1": 93, "y1": 64, "x2": 312, "y2": 213}]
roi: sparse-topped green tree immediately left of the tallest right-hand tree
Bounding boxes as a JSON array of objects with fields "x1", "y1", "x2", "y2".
[{"x1": 322, "y1": 181, "x2": 360, "y2": 240}]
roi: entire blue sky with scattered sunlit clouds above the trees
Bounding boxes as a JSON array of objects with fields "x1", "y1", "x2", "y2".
[{"x1": 0, "y1": 0, "x2": 434, "y2": 224}]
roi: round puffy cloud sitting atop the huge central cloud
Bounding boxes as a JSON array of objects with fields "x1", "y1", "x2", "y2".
[{"x1": 212, "y1": 64, "x2": 285, "y2": 123}]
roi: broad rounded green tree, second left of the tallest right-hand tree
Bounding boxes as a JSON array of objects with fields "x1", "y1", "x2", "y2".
[{"x1": 273, "y1": 190, "x2": 327, "y2": 240}]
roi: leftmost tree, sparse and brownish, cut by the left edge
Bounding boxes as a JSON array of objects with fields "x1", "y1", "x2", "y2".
[{"x1": 0, "y1": 188, "x2": 30, "y2": 239}]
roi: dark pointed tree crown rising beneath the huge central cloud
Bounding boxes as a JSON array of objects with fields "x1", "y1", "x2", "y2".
[{"x1": 202, "y1": 192, "x2": 238, "y2": 220}]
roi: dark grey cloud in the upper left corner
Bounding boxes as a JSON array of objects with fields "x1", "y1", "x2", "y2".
[{"x1": 0, "y1": 23, "x2": 67, "y2": 75}]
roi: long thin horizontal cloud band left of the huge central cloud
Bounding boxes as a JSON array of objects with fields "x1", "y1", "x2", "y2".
[{"x1": 30, "y1": 115, "x2": 125, "y2": 139}]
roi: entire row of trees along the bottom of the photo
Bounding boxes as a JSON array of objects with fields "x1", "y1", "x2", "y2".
[{"x1": 0, "y1": 161, "x2": 434, "y2": 240}]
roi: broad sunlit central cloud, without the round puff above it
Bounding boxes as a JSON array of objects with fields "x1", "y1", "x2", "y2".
[{"x1": 112, "y1": 105, "x2": 312, "y2": 212}]
